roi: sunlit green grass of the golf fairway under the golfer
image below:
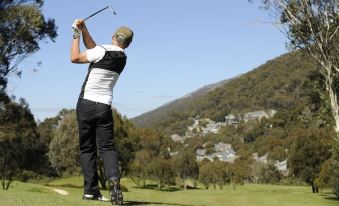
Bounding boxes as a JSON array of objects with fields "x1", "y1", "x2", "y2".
[{"x1": 0, "y1": 177, "x2": 339, "y2": 206}]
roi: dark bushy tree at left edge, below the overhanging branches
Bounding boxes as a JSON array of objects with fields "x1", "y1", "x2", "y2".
[{"x1": 0, "y1": 99, "x2": 49, "y2": 189}]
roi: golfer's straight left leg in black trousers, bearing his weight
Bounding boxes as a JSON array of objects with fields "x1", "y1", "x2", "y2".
[{"x1": 76, "y1": 99, "x2": 100, "y2": 197}]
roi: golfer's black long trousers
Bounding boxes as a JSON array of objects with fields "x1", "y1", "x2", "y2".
[{"x1": 76, "y1": 98, "x2": 119, "y2": 194}]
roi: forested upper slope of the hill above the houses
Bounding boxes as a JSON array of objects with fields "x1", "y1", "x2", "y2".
[{"x1": 132, "y1": 52, "x2": 316, "y2": 134}]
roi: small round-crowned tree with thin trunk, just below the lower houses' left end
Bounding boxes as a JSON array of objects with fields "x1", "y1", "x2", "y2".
[{"x1": 174, "y1": 150, "x2": 199, "y2": 190}]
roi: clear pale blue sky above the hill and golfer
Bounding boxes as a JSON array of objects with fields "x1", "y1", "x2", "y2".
[{"x1": 7, "y1": 0, "x2": 288, "y2": 121}]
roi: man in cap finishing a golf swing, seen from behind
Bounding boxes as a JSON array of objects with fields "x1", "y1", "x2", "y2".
[{"x1": 71, "y1": 19, "x2": 133, "y2": 205}]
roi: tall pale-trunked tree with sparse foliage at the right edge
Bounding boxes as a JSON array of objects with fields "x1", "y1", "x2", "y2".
[{"x1": 254, "y1": 0, "x2": 339, "y2": 134}]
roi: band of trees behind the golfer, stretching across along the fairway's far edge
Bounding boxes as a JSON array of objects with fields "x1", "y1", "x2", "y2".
[{"x1": 2, "y1": 104, "x2": 335, "y2": 197}]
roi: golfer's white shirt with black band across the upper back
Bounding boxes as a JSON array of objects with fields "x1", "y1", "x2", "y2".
[{"x1": 80, "y1": 45, "x2": 127, "y2": 105}]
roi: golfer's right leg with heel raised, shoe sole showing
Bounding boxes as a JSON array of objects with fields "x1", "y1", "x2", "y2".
[{"x1": 96, "y1": 105, "x2": 123, "y2": 205}]
